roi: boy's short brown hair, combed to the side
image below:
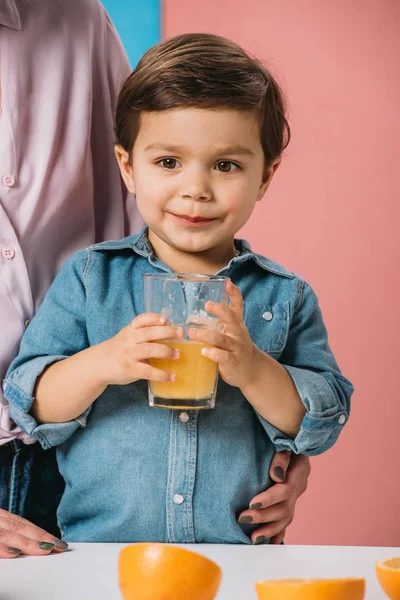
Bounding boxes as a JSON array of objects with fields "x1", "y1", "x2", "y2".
[{"x1": 116, "y1": 33, "x2": 290, "y2": 166}]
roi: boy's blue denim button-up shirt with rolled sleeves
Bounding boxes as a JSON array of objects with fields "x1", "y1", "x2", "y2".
[{"x1": 4, "y1": 229, "x2": 353, "y2": 544}]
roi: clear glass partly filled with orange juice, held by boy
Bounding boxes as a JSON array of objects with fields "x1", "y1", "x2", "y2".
[{"x1": 143, "y1": 273, "x2": 228, "y2": 409}]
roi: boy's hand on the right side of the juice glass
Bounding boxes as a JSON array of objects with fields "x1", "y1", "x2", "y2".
[{"x1": 189, "y1": 281, "x2": 260, "y2": 388}]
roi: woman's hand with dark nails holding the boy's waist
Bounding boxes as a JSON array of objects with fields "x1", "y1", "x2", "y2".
[{"x1": 239, "y1": 451, "x2": 311, "y2": 544}]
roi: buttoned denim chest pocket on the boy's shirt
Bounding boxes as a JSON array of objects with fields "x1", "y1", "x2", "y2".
[{"x1": 244, "y1": 302, "x2": 289, "y2": 354}]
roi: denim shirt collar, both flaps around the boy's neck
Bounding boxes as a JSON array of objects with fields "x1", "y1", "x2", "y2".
[{"x1": 91, "y1": 226, "x2": 294, "y2": 279}]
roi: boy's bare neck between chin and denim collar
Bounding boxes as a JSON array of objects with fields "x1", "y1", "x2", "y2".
[{"x1": 148, "y1": 229, "x2": 235, "y2": 275}]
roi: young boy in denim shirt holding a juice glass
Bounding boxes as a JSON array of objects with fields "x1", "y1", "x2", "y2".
[{"x1": 4, "y1": 34, "x2": 352, "y2": 543}]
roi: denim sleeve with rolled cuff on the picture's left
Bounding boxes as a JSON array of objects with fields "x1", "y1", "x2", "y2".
[{"x1": 3, "y1": 250, "x2": 90, "y2": 449}]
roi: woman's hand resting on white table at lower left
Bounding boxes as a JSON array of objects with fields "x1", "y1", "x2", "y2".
[{"x1": 0, "y1": 509, "x2": 68, "y2": 558}]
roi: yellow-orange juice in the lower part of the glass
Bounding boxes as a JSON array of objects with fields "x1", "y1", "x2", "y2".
[{"x1": 149, "y1": 340, "x2": 218, "y2": 408}]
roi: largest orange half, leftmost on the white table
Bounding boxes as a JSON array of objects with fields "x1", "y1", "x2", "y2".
[{"x1": 118, "y1": 543, "x2": 222, "y2": 600}]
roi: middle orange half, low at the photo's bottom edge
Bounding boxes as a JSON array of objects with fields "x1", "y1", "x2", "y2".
[{"x1": 256, "y1": 578, "x2": 365, "y2": 600}]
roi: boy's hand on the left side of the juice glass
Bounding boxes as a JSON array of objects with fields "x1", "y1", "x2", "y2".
[{"x1": 101, "y1": 313, "x2": 183, "y2": 385}]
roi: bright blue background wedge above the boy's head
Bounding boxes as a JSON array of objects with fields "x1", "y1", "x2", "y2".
[{"x1": 102, "y1": 0, "x2": 161, "y2": 68}]
